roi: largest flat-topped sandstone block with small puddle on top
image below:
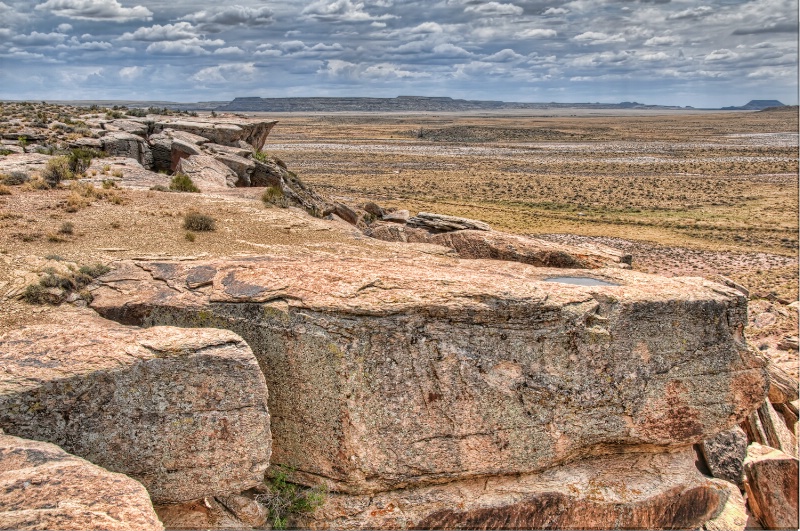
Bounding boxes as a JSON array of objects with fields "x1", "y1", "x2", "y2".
[{"x1": 92, "y1": 252, "x2": 768, "y2": 494}]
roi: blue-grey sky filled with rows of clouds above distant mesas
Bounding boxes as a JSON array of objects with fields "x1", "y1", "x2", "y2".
[{"x1": 0, "y1": 0, "x2": 798, "y2": 107}]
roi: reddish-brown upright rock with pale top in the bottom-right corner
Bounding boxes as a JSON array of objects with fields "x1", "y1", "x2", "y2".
[{"x1": 744, "y1": 443, "x2": 798, "y2": 529}]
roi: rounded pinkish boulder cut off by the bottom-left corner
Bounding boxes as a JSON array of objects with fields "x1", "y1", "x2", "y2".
[{"x1": 0, "y1": 434, "x2": 164, "y2": 531}]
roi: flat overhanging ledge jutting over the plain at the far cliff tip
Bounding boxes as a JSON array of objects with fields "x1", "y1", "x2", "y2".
[{"x1": 153, "y1": 118, "x2": 278, "y2": 150}]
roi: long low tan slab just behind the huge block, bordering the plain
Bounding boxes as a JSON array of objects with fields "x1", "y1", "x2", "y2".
[{"x1": 364, "y1": 222, "x2": 629, "y2": 269}]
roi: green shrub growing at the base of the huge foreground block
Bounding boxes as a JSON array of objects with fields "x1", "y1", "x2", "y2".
[{"x1": 256, "y1": 466, "x2": 327, "y2": 529}]
